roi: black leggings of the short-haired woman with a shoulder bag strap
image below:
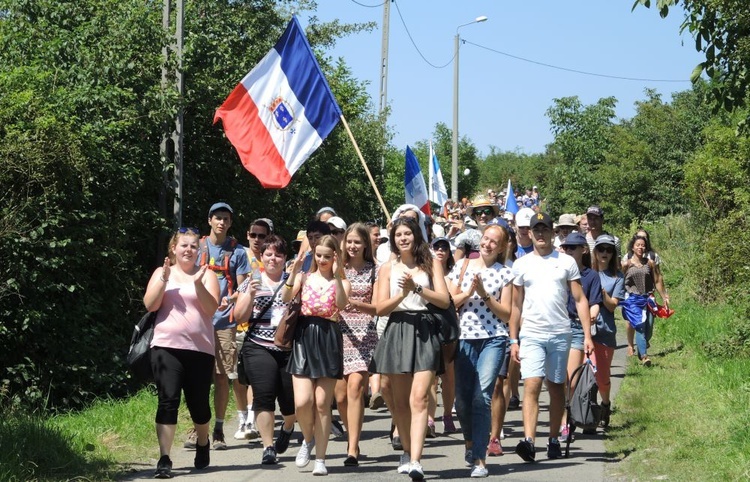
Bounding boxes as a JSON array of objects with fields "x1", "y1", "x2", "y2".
[{"x1": 240, "y1": 338, "x2": 294, "y2": 415}]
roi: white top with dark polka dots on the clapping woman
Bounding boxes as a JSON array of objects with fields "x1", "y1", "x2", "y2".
[{"x1": 448, "y1": 258, "x2": 513, "y2": 340}]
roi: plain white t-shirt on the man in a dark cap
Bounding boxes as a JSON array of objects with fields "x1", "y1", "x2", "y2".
[{"x1": 513, "y1": 251, "x2": 581, "y2": 336}]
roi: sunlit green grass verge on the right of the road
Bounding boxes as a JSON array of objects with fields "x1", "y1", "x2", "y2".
[{"x1": 607, "y1": 219, "x2": 750, "y2": 481}]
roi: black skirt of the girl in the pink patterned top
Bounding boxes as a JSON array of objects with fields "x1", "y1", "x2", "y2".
[{"x1": 286, "y1": 316, "x2": 344, "y2": 379}]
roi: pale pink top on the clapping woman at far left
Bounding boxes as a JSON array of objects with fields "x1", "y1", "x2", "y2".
[{"x1": 151, "y1": 280, "x2": 214, "y2": 355}]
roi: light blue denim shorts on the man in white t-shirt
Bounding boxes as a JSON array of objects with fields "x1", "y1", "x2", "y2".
[{"x1": 519, "y1": 333, "x2": 571, "y2": 383}]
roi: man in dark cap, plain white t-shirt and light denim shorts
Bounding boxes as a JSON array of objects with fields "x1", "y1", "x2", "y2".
[{"x1": 510, "y1": 212, "x2": 594, "y2": 462}]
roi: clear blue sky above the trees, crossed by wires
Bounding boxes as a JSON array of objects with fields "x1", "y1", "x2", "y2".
[{"x1": 300, "y1": 0, "x2": 702, "y2": 155}]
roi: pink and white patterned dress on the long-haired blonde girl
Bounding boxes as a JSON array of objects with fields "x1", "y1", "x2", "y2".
[{"x1": 339, "y1": 262, "x2": 378, "y2": 375}]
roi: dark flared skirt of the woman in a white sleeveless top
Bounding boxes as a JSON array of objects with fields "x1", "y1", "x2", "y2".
[{"x1": 370, "y1": 311, "x2": 445, "y2": 374}]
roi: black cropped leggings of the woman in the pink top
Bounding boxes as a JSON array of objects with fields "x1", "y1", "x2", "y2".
[{"x1": 151, "y1": 346, "x2": 214, "y2": 425}]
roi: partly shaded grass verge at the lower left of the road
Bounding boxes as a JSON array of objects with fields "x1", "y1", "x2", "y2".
[{"x1": 0, "y1": 385, "x2": 200, "y2": 481}]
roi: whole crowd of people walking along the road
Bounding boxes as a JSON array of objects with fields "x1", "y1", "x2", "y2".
[{"x1": 144, "y1": 194, "x2": 669, "y2": 480}]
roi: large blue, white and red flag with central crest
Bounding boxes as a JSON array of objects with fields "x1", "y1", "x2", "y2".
[{"x1": 214, "y1": 17, "x2": 341, "y2": 188}]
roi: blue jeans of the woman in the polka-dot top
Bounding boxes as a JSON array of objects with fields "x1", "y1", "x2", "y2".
[{"x1": 455, "y1": 336, "x2": 508, "y2": 460}]
